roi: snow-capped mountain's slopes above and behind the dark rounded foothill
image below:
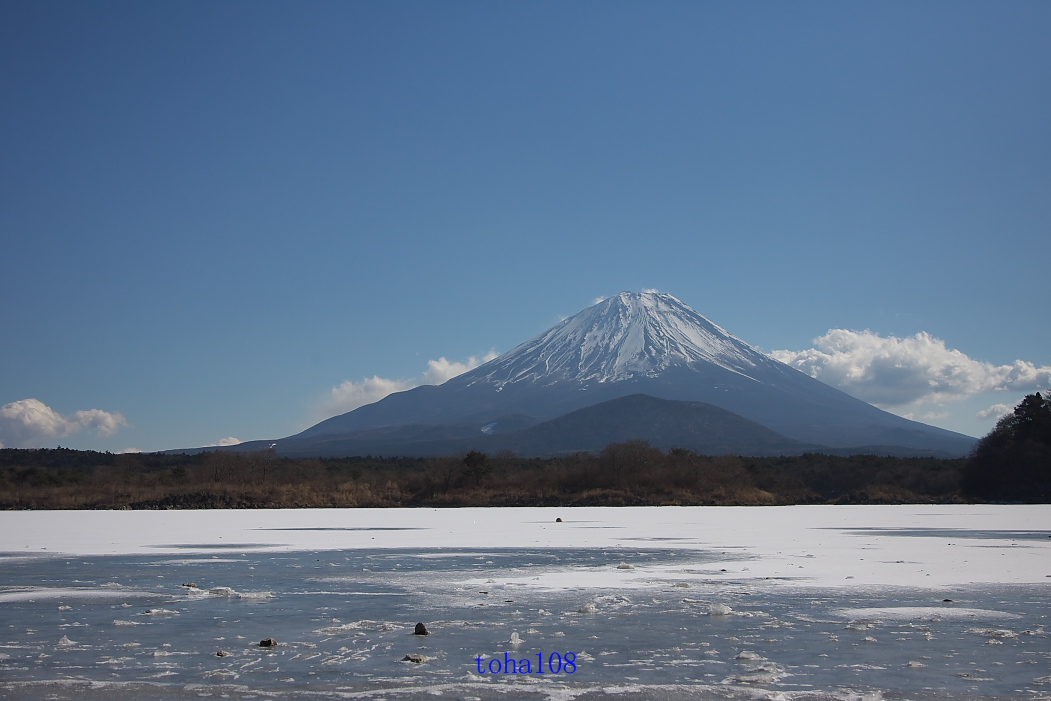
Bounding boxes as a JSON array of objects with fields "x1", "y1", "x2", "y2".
[{"x1": 294, "y1": 292, "x2": 973, "y2": 454}]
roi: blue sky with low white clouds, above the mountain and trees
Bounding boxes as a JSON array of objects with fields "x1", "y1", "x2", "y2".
[{"x1": 0, "y1": 0, "x2": 1051, "y2": 452}]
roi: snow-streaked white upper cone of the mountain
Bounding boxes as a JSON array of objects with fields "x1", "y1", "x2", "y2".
[{"x1": 469, "y1": 292, "x2": 769, "y2": 388}]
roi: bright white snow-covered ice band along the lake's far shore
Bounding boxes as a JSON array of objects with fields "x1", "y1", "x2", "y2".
[{"x1": 0, "y1": 504, "x2": 1051, "y2": 598}]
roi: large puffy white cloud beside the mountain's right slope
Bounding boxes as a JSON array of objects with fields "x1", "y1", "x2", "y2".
[{"x1": 770, "y1": 329, "x2": 1051, "y2": 409}]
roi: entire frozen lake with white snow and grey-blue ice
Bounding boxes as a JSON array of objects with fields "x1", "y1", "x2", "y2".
[{"x1": 0, "y1": 504, "x2": 1051, "y2": 700}]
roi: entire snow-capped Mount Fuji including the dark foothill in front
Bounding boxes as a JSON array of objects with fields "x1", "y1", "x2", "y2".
[{"x1": 236, "y1": 292, "x2": 974, "y2": 456}]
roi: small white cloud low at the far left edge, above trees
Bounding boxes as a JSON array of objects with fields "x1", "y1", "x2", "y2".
[{"x1": 0, "y1": 398, "x2": 128, "y2": 448}]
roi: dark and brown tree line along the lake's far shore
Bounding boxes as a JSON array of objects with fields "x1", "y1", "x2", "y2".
[{"x1": 0, "y1": 394, "x2": 1051, "y2": 509}]
